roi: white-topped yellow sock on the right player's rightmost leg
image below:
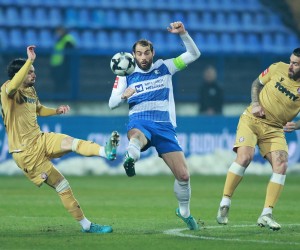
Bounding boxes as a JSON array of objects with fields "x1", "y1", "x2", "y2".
[{"x1": 264, "y1": 173, "x2": 286, "y2": 211}]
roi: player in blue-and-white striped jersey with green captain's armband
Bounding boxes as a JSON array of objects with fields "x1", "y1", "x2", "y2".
[{"x1": 109, "y1": 22, "x2": 200, "y2": 230}]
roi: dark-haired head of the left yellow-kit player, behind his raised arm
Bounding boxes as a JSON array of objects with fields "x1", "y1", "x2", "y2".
[{"x1": 7, "y1": 58, "x2": 36, "y2": 87}]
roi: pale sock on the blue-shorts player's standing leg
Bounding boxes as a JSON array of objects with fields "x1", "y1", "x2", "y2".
[{"x1": 174, "y1": 179, "x2": 191, "y2": 218}]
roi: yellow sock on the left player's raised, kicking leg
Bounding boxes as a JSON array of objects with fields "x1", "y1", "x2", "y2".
[{"x1": 72, "y1": 139, "x2": 100, "y2": 156}]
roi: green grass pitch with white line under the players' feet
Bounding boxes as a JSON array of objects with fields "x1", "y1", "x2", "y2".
[{"x1": 0, "y1": 175, "x2": 300, "y2": 250}]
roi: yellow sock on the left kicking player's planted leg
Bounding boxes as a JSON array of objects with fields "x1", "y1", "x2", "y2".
[{"x1": 58, "y1": 188, "x2": 84, "y2": 221}]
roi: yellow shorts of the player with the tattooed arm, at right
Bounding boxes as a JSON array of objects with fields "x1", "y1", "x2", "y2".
[{"x1": 233, "y1": 114, "x2": 288, "y2": 157}]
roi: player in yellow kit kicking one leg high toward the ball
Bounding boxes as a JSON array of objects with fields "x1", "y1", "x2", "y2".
[{"x1": 1, "y1": 46, "x2": 119, "y2": 233}]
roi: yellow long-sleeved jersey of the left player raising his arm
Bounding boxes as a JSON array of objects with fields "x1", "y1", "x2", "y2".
[{"x1": 0, "y1": 60, "x2": 55, "y2": 153}]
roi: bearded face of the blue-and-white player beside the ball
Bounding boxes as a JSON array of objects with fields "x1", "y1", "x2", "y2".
[{"x1": 134, "y1": 44, "x2": 154, "y2": 71}]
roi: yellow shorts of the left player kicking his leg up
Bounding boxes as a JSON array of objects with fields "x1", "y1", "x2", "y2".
[{"x1": 12, "y1": 133, "x2": 69, "y2": 186}]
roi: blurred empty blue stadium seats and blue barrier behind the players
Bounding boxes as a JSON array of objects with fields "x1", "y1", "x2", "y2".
[{"x1": 0, "y1": 0, "x2": 300, "y2": 113}]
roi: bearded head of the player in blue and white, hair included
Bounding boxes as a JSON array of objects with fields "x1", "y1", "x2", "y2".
[{"x1": 132, "y1": 39, "x2": 155, "y2": 71}]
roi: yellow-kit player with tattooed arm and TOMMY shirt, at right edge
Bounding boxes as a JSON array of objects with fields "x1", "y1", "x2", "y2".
[{"x1": 217, "y1": 48, "x2": 300, "y2": 230}]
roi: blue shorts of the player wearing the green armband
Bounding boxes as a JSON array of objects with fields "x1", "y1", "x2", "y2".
[{"x1": 127, "y1": 120, "x2": 182, "y2": 155}]
